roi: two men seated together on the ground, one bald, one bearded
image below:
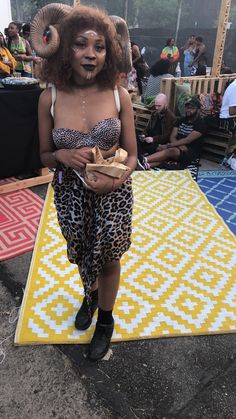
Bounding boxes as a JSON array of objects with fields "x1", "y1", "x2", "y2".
[{"x1": 137, "y1": 93, "x2": 207, "y2": 170}]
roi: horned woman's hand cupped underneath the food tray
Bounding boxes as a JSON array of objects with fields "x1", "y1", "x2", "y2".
[{"x1": 84, "y1": 171, "x2": 115, "y2": 195}]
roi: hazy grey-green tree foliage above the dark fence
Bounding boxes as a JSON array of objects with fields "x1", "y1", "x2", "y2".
[{"x1": 11, "y1": 0, "x2": 236, "y2": 32}]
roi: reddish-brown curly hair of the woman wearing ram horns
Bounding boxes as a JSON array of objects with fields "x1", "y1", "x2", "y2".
[{"x1": 38, "y1": 6, "x2": 121, "y2": 90}]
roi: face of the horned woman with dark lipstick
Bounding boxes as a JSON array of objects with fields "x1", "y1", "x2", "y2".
[{"x1": 71, "y1": 29, "x2": 106, "y2": 82}]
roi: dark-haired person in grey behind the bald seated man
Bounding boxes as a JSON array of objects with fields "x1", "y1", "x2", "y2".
[{"x1": 143, "y1": 60, "x2": 173, "y2": 103}]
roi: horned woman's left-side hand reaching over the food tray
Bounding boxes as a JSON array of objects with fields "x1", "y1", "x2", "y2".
[{"x1": 56, "y1": 147, "x2": 92, "y2": 170}]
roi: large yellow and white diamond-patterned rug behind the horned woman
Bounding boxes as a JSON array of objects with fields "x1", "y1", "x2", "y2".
[{"x1": 15, "y1": 171, "x2": 236, "y2": 345}]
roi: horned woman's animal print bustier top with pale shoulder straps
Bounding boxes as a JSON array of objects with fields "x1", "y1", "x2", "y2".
[{"x1": 51, "y1": 85, "x2": 121, "y2": 150}]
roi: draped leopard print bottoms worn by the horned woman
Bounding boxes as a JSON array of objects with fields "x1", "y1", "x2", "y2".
[{"x1": 53, "y1": 169, "x2": 133, "y2": 301}]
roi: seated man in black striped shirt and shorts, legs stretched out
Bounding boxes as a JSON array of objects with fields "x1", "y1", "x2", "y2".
[{"x1": 138, "y1": 97, "x2": 206, "y2": 170}]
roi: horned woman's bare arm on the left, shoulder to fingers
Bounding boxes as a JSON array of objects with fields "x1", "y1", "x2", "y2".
[{"x1": 38, "y1": 89, "x2": 92, "y2": 170}]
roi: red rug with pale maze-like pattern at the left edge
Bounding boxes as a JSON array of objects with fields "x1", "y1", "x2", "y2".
[{"x1": 0, "y1": 189, "x2": 44, "y2": 261}]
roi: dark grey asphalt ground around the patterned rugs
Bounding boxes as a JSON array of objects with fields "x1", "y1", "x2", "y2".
[{"x1": 0, "y1": 185, "x2": 236, "y2": 419}]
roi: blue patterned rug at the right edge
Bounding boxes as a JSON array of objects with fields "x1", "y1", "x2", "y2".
[{"x1": 198, "y1": 170, "x2": 236, "y2": 234}]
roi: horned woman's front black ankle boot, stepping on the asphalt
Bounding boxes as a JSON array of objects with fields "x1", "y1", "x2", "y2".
[{"x1": 87, "y1": 320, "x2": 114, "y2": 361}]
